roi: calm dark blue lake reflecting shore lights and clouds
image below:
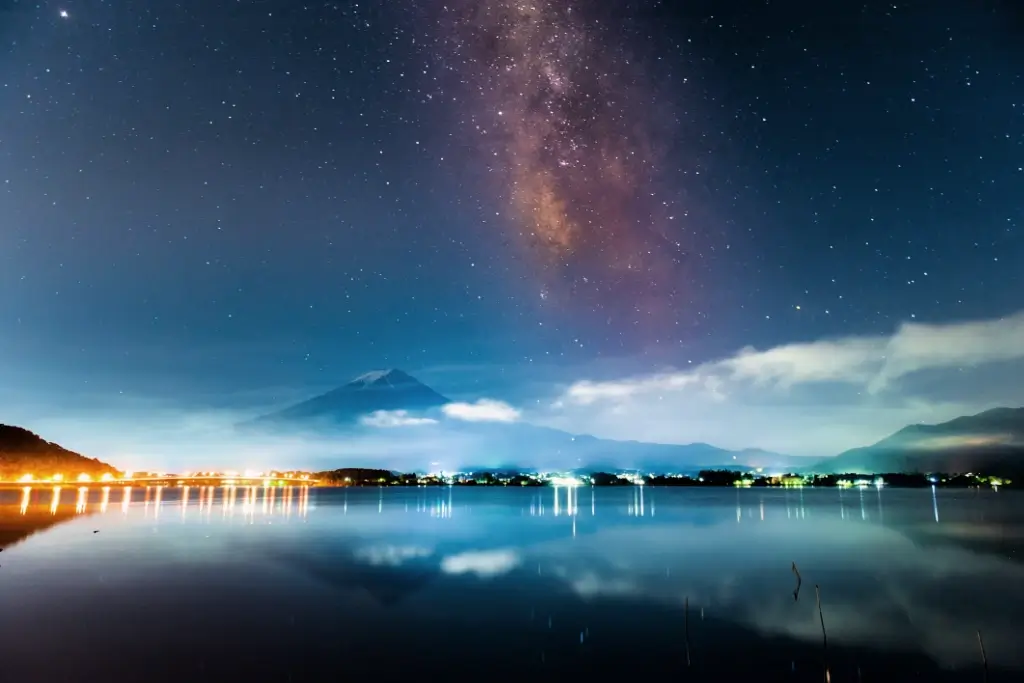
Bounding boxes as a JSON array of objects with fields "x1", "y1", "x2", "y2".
[{"x1": 0, "y1": 486, "x2": 1024, "y2": 682}]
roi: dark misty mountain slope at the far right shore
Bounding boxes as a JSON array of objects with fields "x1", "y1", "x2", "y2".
[{"x1": 816, "y1": 408, "x2": 1024, "y2": 474}]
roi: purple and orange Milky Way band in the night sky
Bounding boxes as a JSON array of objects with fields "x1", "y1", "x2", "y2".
[{"x1": 442, "y1": 0, "x2": 685, "y2": 309}]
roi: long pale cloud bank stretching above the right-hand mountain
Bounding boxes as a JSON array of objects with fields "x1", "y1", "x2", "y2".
[{"x1": 548, "y1": 311, "x2": 1024, "y2": 456}]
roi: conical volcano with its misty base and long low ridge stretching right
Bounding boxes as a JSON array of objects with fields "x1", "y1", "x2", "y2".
[{"x1": 244, "y1": 370, "x2": 800, "y2": 471}]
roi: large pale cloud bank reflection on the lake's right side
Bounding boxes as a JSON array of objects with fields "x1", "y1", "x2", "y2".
[{"x1": 529, "y1": 520, "x2": 1024, "y2": 666}]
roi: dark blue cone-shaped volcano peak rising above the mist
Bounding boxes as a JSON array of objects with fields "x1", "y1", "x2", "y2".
[{"x1": 250, "y1": 370, "x2": 451, "y2": 426}]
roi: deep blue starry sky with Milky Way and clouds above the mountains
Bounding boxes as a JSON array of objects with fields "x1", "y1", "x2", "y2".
[{"x1": 0, "y1": 0, "x2": 1024, "y2": 464}]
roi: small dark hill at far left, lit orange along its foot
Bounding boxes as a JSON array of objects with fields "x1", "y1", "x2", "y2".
[{"x1": 0, "y1": 425, "x2": 118, "y2": 481}]
